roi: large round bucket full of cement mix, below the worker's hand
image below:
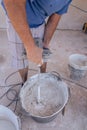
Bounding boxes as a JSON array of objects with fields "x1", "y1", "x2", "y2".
[{"x1": 19, "y1": 73, "x2": 69, "y2": 123}]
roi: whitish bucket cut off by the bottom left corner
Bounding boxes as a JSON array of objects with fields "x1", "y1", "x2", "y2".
[{"x1": 0, "y1": 105, "x2": 21, "y2": 130}]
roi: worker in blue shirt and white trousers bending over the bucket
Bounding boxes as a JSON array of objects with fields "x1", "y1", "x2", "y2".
[{"x1": 2, "y1": 0, "x2": 72, "y2": 82}]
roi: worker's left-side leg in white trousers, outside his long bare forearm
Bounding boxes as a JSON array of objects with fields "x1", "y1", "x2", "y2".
[{"x1": 7, "y1": 18, "x2": 28, "y2": 82}]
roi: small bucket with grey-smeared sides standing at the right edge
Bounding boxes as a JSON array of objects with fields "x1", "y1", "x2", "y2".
[{"x1": 69, "y1": 54, "x2": 87, "y2": 80}]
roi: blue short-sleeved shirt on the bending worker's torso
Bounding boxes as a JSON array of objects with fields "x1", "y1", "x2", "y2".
[{"x1": 2, "y1": 0, "x2": 72, "y2": 27}]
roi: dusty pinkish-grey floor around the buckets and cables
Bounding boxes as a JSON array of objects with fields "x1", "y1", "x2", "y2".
[{"x1": 0, "y1": 0, "x2": 87, "y2": 130}]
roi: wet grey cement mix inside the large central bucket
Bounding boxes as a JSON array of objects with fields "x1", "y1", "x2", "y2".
[{"x1": 22, "y1": 73, "x2": 68, "y2": 117}]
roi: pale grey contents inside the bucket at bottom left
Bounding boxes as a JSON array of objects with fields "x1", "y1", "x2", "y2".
[{"x1": 0, "y1": 119, "x2": 16, "y2": 130}]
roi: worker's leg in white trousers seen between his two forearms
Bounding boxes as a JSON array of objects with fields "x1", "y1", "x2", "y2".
[{"x1": 31, "y1": 24, "x2": 51, "y2": 73}]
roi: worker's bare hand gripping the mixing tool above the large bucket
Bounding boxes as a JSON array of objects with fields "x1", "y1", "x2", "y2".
[{"x1": 26, "y1": 45, "x2": 43, "y2": 65}]
